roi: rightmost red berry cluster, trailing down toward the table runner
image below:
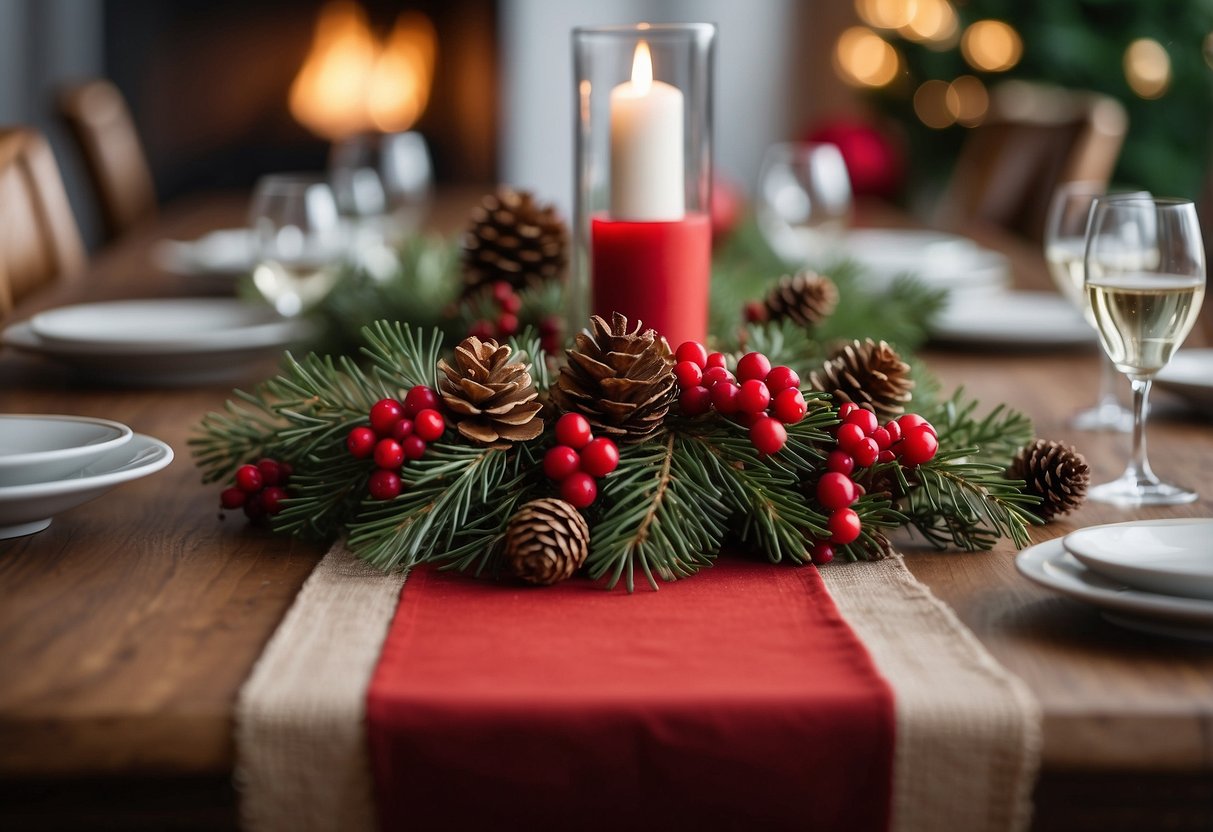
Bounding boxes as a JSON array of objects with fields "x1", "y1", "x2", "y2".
[{"x1": 810, "y1": 401, "x2": 939, "y2": 564}]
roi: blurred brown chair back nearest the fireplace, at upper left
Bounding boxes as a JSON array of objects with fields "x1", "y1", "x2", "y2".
[{"x1": 58, "y1": 80, "x2": 156, "y2": 239}]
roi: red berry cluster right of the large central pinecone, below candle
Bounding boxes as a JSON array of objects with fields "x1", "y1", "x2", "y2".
[{"x1": 674, "y1": 341, "x2": 809, "y2": 454}]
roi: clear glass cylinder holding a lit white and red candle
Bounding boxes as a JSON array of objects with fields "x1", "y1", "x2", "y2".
[{"x1": 569, "y1": 23, "x2": 716, "y2": 346}]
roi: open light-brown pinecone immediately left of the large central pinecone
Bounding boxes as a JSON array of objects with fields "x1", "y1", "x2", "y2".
[{"x1": 438, "y1": 336, "x2": 543, "y2": 445}]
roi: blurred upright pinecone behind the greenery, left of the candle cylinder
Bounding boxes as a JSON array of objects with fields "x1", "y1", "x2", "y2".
[{"x1": 463, "y1": 188, "x2": 569, "y2": 295}]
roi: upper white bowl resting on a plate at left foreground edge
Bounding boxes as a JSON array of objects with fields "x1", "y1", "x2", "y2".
[{"x1": 0, "y1": 414, "x2": 131, "y2": 486}]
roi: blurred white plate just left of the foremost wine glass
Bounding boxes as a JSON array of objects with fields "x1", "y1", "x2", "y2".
[{"x1": 932, "y1": 292, "x2": 1095, "y2": 348}]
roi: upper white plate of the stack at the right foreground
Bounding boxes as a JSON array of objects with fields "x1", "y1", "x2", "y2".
[{"x1": 1063, "y1": 518, "x2": 1213, "y2": 600}]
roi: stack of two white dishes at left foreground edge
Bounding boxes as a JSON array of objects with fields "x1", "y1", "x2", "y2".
[{"x1": 0, "y1": 414, "x2": 172, "y2": 540}]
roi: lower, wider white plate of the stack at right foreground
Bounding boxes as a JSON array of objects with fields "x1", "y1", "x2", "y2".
[{"x1": 1015, "y1": 540, "x2": 1213, "y2": 642}]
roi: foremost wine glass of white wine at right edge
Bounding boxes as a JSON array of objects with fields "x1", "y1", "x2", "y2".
[{"x1": 1083, "y1": 196, "x2": 1205, "y2": 506}]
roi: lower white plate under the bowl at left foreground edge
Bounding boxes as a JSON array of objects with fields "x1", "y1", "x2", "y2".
[{"x1": 0, "y1": 433, "x2": 172, "y2": 540}]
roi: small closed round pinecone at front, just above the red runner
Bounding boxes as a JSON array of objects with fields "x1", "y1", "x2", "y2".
[{"x1": 506, "y1": 497, "x2": 590, "y2": 586}]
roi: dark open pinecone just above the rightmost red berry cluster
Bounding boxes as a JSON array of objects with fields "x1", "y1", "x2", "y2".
[{"x1": 809, "y1": 338, "x2": 913, "y2": 422}]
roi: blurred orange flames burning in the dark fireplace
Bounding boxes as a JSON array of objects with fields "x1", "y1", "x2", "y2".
[{"x1": 290, "y1": 0, "x2": 438, "y2": 139}]
